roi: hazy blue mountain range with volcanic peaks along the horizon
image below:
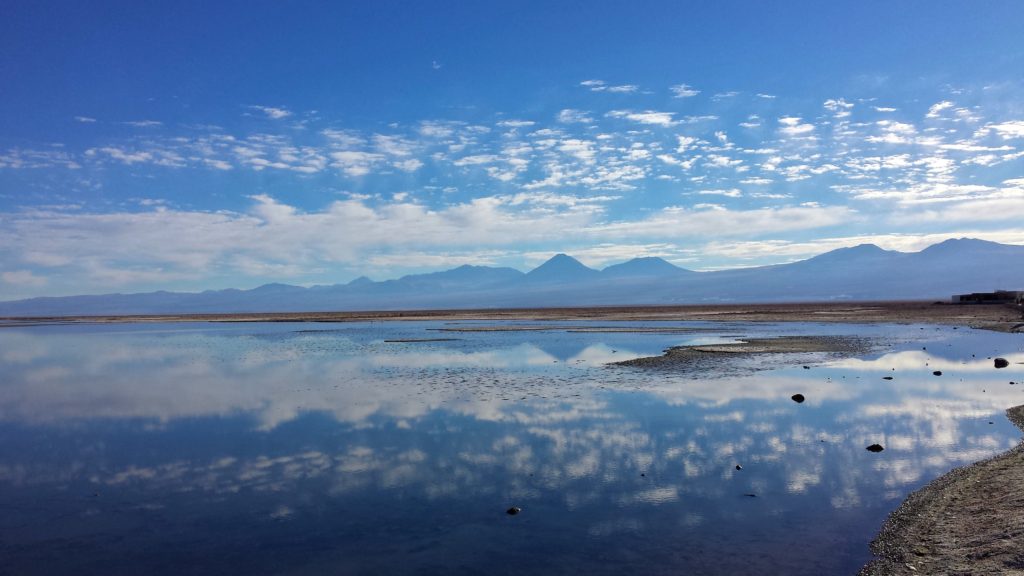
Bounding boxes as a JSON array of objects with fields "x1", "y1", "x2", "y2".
[{"x1": 0, "y1": 238, "x2": 1024, "y2": 317}]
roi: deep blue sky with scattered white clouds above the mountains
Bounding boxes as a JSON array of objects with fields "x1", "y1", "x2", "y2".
[{"x1": 0, "y1": 1, "x2": 1024, "y2": 299}]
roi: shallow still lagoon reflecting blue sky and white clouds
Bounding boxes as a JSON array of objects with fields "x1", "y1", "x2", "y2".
[{"x1": 0, "y1": 322, "x2": 1024, "y2": 574}]
